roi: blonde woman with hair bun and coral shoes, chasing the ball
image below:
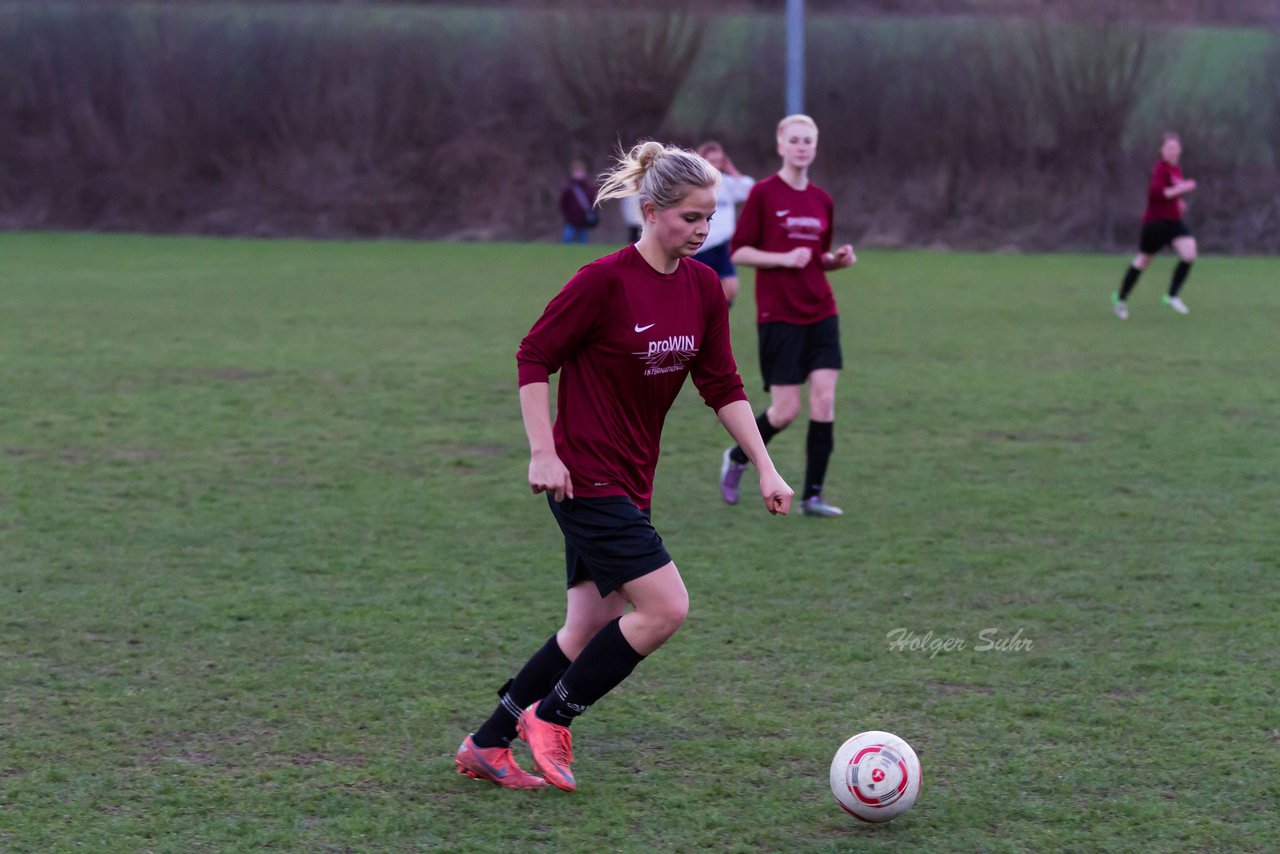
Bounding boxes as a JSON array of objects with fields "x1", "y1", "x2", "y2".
[{"x1": 457, "y1": 142, "x2": 791, "y2": 790}]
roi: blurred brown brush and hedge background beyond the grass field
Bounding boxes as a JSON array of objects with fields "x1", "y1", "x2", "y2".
[{"x1": 0, "y1": 0, "x2": 1280, "y2": 252}]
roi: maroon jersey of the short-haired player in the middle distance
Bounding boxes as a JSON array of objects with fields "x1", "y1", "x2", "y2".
[{"x1": 731, "y1": 175, "x2": 836, "y2": 324}]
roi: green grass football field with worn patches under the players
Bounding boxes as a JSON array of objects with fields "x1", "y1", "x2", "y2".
[{"x1": 0, "y1": 234, "x2": 1280, "y2": 851}]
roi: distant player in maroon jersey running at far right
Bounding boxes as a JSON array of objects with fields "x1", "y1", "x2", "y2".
[{"x1": 1111, "y1": 133, "x2": 1196, "y2": 320}]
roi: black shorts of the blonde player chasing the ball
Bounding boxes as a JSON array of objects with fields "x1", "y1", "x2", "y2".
[{"x1": 547, "y1": 494, "x2": 671, "y2": 599}]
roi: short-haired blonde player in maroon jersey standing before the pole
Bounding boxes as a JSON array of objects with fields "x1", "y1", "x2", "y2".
[{"x1": 719, "y1": 115, "x2": 856, "y2": 516}]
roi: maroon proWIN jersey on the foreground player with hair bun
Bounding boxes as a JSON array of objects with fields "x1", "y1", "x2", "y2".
[{"x1": 516, "y1": 246, "x2": 746, "y2": 510}]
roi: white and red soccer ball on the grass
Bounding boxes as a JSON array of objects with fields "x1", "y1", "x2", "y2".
[{"x1": 831, "y1": 730, "x2": 920, "y2": 822}]
